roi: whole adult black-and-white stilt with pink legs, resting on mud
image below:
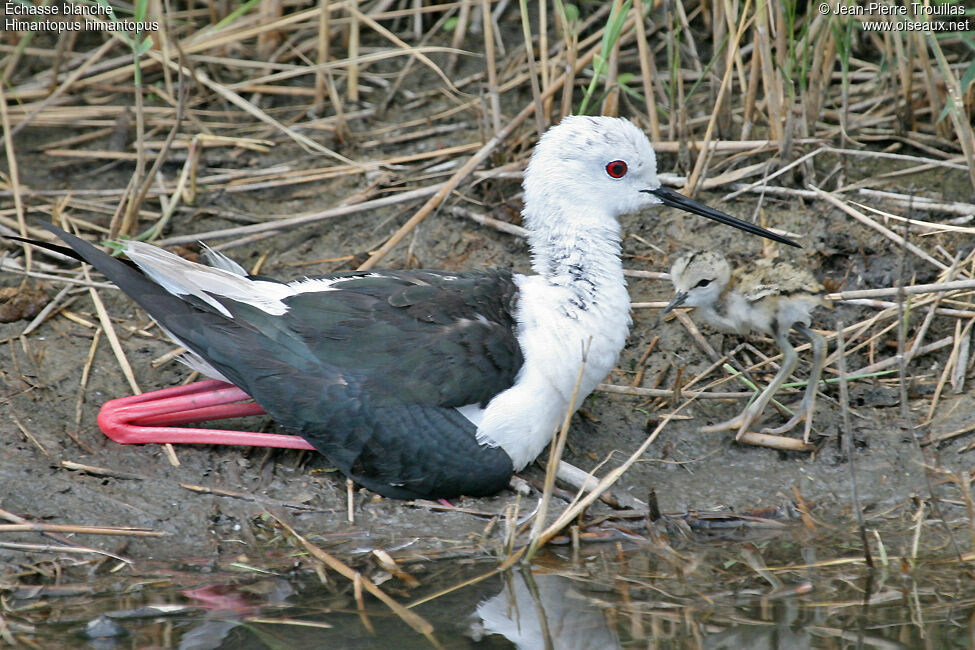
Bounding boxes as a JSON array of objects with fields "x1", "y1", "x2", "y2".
[{"x1": 11, "y1": 117, "x2": 794, "y2": 498}]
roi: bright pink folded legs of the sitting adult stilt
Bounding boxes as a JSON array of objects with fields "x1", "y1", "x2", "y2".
[{"x1": 98, "y1": 379, "x2": 314, "y2": 449}]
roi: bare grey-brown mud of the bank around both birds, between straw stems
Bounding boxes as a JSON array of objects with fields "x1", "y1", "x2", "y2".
[{"x1": 0, "y1": 153, "x2": 973, "y2": 561}]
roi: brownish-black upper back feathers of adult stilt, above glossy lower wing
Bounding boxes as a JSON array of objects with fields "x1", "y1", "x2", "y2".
[{"x1": 282, "y1": 270, "x2": 523, "y2": 406}]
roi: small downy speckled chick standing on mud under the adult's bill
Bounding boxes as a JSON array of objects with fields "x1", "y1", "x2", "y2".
[{"x1": 664, "y1": 251, "x2": 832, "y2": 443}]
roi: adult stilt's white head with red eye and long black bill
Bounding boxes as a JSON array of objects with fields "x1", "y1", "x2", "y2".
[{"x1": 523, "y1": 115, "x2": 798, "y2": 246}]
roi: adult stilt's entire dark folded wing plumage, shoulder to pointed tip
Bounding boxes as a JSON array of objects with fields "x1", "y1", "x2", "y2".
[{"x1": 26, "y1": 226, "x2": 522, "y2": 498}]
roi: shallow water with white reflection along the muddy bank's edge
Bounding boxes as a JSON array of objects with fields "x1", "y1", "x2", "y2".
[{"x1": 17, "y1": 523, "x2": 975, "y2": 650}]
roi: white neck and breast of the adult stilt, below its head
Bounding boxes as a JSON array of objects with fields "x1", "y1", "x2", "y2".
[{"x1": 468, "y1": 203, "x2": 630, "y2": 470}]
